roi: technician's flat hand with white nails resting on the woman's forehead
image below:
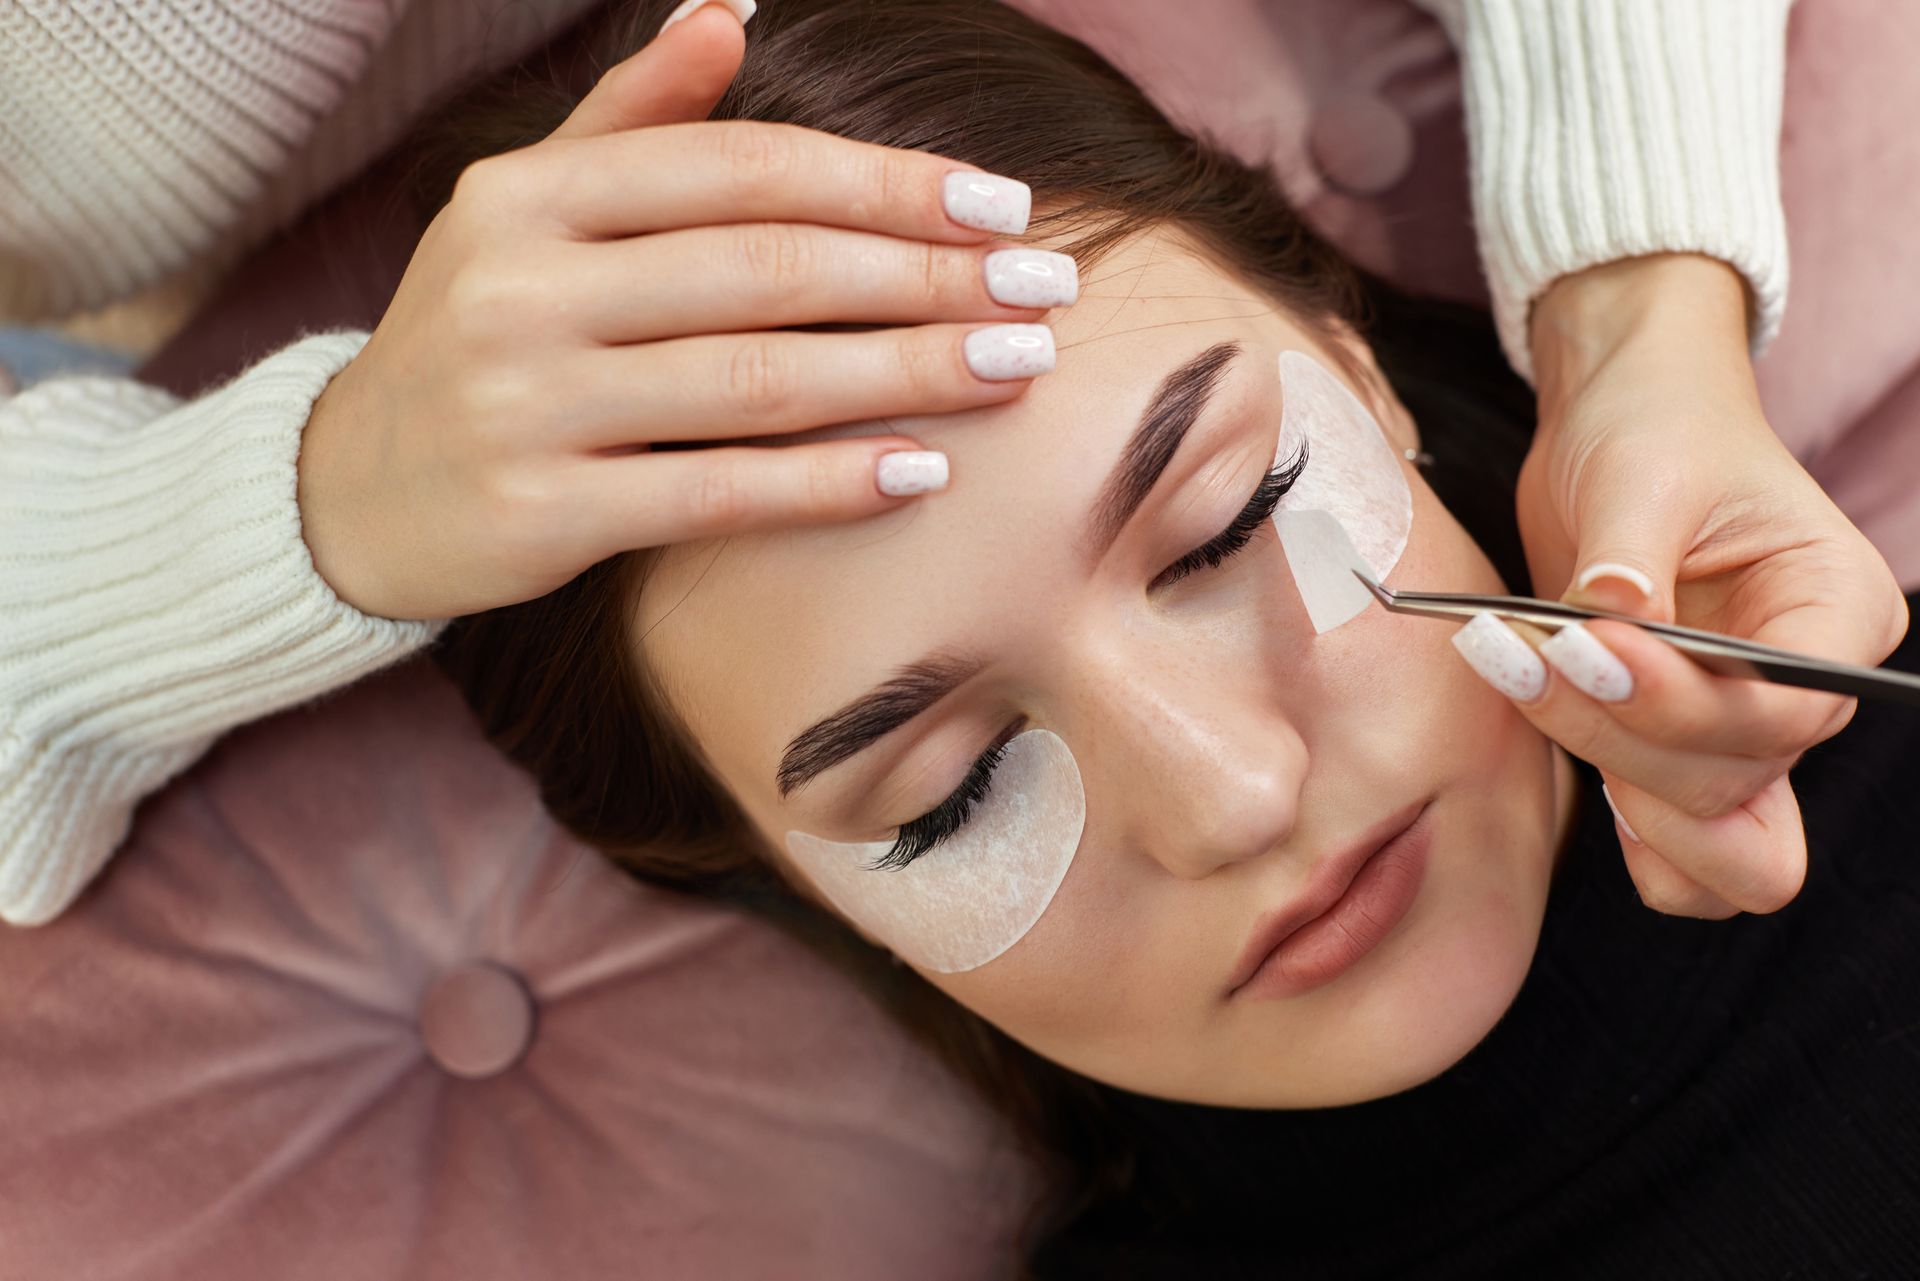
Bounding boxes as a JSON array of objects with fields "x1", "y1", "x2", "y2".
[{"x1": 300, "y1": 4, "x2": 1077, "y2": 618}]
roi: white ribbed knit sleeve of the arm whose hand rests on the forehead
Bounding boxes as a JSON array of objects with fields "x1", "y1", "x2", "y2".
[{"x1": 0, "y1": 330, "x2": 447, "y2": 926}]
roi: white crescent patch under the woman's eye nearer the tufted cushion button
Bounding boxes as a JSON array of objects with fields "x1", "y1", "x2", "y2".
[{"x1": 787, "y1": 730, "x2": 1087, "y2": 974}]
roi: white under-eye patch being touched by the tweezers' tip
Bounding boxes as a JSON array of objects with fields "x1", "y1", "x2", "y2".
[{"x1": 1273, "y1": 351, "x2": 1413, "y2": 632}]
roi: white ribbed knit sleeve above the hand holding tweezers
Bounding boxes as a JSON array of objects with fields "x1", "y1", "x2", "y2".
[{"x1": 1415, "y1": 0, "x2": 1793, "y2": 378}]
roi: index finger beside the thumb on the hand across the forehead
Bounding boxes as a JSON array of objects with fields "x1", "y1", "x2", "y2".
[{"x1": 516, "y1": 121, "x2": 1031, "y2": 244}]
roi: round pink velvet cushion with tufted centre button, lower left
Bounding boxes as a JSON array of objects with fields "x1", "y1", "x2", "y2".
[{"x1": 0, "y1": 659, "x2": 1031, "y2": 1281}]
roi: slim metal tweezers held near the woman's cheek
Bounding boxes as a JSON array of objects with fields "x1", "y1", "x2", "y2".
[{"x1": 1354, "y1": 567, "x2": 1920, "y2": 707}]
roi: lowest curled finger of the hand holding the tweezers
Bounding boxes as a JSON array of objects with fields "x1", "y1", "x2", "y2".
[{"x1": 1607, "y1": 778, "x2": 1807, "y2": 916}]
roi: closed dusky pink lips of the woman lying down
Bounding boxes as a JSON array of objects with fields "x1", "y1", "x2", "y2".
[{"x1": 1238, "y1": 807, "x2": 1432, "y2": 1001}]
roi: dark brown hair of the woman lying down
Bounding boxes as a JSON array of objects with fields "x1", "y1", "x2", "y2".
[{"x1": 401, "y1": 0, "x2": 1511, "y2": 1241}]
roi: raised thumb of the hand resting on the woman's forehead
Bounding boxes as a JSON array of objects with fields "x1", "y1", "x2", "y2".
[{"x1": 549, "y1": 0, "x2": 755, "y2": 138}]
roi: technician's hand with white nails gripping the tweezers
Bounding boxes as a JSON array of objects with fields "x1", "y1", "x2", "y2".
[{"x1": 1519, "y1": 255, "x2": 1907, "y2": 918}]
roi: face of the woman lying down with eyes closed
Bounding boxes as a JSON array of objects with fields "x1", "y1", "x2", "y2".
[{"x1": 636, "y1": 232, "x2": 1571, "y2": 1108}]
